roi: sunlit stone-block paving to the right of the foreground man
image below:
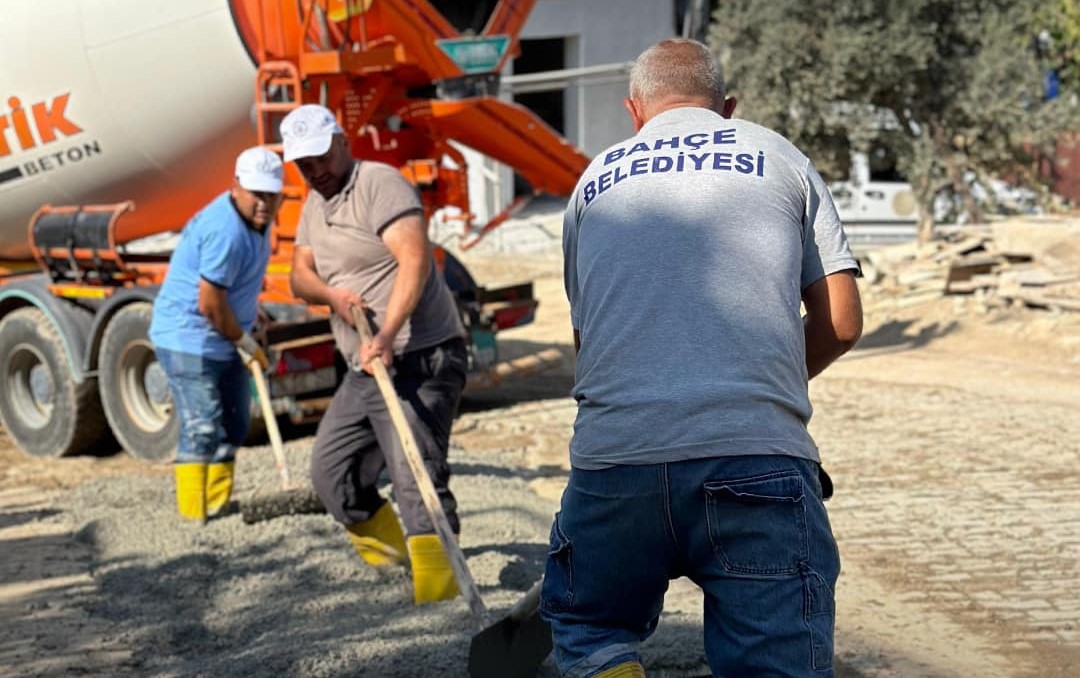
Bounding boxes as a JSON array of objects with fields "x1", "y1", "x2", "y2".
[{"x1": 814, "y1": 362, "x2": 1080, "y2": 676}]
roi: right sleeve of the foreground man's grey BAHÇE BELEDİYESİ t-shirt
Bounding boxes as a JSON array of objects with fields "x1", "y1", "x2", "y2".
[{"x1": 800, "y1": 160, "x2": 859, "y2": 289}]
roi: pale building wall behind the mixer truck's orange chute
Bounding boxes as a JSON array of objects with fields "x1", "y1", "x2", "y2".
[{"x1": 464, "y1": 0, "x2": 675, "y2": 226}]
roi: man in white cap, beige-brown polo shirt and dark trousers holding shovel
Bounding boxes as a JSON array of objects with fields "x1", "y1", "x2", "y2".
[{"x1": 281, "y1": 104, "x2": 468, "y2": 605}]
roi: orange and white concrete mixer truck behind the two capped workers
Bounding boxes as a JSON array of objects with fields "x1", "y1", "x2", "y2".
[{"x1": 0, "y1": 0, "x2": 588, "y2": 460}]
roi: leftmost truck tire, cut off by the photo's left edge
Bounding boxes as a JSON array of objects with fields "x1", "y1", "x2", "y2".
[{"x1": 0, "y1": 308, "x2": 106, "y2": 457}]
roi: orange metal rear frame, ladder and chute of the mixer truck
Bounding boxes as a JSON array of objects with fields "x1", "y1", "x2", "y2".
[{"x1": 231, "y1": 0, "x2": 589, "y2": 264}]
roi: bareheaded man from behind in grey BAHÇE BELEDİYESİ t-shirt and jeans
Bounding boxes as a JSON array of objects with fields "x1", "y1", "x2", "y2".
[{"x1": 541, "y1": 40, "x2": 862, "y2": 677}]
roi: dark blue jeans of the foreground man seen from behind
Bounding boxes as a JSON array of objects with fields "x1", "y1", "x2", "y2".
[{"x1": 540, "y1": 456, "x2": 840, "y2": 678}]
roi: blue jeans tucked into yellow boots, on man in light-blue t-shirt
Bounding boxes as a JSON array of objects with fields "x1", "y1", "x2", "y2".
[{"x1": 154, "y1": 347, "x2": 252, "y2": 463}]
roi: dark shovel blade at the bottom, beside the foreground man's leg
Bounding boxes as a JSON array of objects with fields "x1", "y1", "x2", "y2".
[{"x1": 469, "y1": 612, "x2": 551, "y2": 678}]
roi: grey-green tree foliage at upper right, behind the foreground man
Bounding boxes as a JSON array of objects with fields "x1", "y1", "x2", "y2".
[{"x1": 708, "y1": 0, "x2": 1080, "y2": 235}]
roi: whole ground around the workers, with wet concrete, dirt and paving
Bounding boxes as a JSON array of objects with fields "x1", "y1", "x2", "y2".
[{"x1": 0, "y1": 245, "x2": 1080, "y2": 678}]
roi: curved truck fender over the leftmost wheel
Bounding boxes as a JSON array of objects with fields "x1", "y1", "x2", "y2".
[{"x1": 0, "y1": 275, "x2": 94, "y2": 383}]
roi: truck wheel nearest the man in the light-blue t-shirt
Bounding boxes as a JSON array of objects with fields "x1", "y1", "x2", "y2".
[{"x1": 97, "y1": 302, "x2": 179, "y2": 462}]
